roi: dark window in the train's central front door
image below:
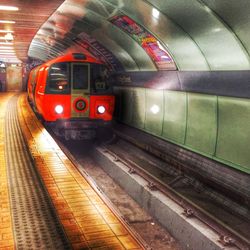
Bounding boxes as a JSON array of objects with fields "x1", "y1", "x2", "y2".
[{"x1": 72, "y1": 64, "x2": 89, "y2": 89}]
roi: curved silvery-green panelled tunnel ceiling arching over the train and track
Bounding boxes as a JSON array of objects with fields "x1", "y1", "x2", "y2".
[{"x1": 28, "y1": 0, "x2": 250, "y2": 71}]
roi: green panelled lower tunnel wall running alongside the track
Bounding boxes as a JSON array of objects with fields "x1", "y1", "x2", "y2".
[{"x1": 114, "y1": 86, "x2": 250, "y2": 173}]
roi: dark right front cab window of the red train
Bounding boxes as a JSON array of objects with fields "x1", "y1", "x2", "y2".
[{"x1": 91, "y1": 64, "x2": 112, "y2": 94}]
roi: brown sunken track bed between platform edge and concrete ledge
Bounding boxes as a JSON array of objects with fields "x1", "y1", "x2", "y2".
[{"x1": 49, "y1": 133, "x2": 180, "y2": 250}]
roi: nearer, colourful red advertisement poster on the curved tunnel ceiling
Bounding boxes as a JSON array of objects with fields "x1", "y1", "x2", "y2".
[{"x1": 109, "y1": 15, "x2": 176, "y2": 70}]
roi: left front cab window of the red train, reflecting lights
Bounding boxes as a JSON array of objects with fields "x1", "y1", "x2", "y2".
[{"x1": 48, "y1": 63, "x2": 70, "y2": 94}]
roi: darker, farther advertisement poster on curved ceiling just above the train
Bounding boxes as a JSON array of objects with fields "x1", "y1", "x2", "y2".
[{"x1": 74, "y1": 32, "x2": 123, "y2": 71}]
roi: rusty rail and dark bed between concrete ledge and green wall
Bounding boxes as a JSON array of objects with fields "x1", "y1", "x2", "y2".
[{"x1": 102, "y1": 135, "x2": 250, "y2": 250}]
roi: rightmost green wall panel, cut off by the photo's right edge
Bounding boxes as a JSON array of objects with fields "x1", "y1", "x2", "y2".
[{"x1": 216, "y1": 97, "x2": 250, "y2": 170}]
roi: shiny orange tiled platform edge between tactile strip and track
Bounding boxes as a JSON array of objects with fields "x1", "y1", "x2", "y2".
[{"x1": 18, "y1": 95, "x2": 143, "y2": 249}]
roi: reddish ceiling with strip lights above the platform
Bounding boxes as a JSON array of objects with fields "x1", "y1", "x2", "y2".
[{"x1": 0, "y1": 0, "x2": 63, "y2": 62}]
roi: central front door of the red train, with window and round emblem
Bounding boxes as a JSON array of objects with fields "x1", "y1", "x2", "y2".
[{"x1": 71, "y1": 63, "x2": 90, "y2": 118}]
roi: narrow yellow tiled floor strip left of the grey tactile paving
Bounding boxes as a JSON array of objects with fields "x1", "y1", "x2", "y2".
[{"x1": 0, "y1": 93, "x2": 15, "y2": 250}]
